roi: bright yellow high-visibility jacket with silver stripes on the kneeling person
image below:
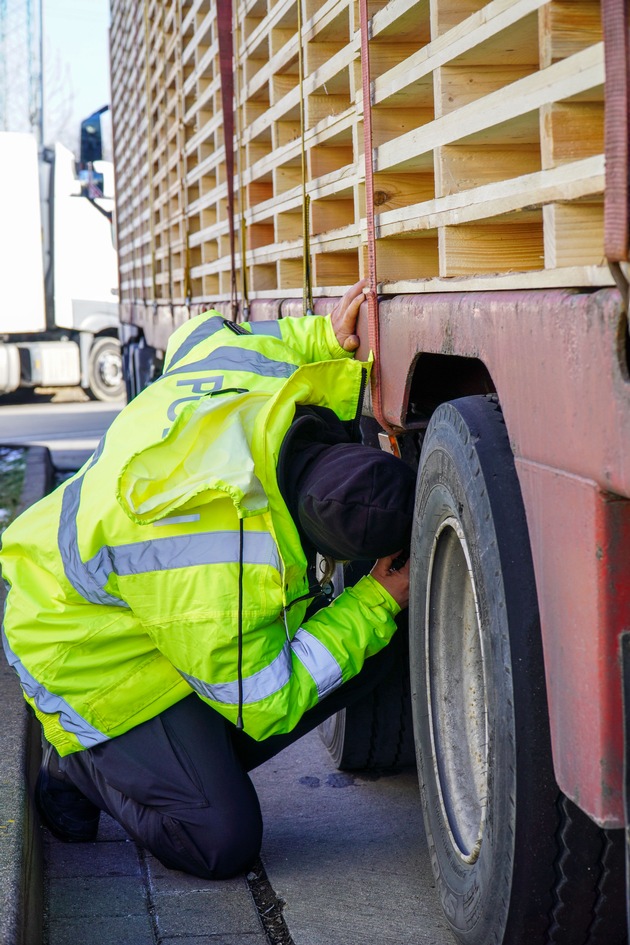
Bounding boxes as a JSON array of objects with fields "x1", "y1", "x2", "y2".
[{"x1": 1, "y1": 312, "x2": 399, "y2": 755}]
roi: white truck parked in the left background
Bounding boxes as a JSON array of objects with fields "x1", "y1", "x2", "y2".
[{"x1": 0, "y1": 110, "x2": 125, "y2": 401}]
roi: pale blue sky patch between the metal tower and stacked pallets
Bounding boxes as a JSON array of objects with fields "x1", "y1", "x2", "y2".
[{"x1": 43, "y1": 0, "x2": 110, "y2": 146}]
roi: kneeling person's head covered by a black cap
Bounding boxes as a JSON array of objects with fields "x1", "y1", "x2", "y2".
[{"x1": 292, "y1": 443, "x2": 416, "y2": 561}]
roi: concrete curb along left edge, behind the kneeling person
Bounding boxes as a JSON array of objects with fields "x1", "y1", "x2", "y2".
[{"x1": 0, "y1": 444, "x2": 53, "y2": 945}]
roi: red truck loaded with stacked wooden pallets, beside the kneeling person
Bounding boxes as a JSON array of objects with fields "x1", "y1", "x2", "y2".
[{"x1": 111, "y1": 0, "x2": 630, "y2": 945}]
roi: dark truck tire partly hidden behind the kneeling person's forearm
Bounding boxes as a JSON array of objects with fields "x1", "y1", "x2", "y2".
[{"x1": 319, "y1": 615, "x2": 415, "y2": 771}]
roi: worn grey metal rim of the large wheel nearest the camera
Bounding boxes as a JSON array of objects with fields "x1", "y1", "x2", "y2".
[{"x1": 425, "y1": 517, "x2": 488, "y2": 863}]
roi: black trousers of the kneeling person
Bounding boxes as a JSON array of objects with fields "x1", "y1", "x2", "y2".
[{"x1": 60, "y1": 633, "x2": 403, "y2": 879}]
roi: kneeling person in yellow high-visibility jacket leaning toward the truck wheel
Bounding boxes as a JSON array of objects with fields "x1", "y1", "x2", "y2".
[{"x1": 1, "y1": 282, "x2": 414, "y2": 879}]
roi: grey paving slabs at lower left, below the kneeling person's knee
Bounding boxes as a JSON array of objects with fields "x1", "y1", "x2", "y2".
[{"x1": 44, "y1": 814, "x2": 267, "y2": 945}]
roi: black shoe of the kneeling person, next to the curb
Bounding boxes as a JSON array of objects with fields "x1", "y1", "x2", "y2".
[{"x1": 35, "y1": 744, "x2": 101, "y2": 843}]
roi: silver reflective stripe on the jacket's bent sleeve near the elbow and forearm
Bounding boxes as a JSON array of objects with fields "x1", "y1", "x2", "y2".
[{"x1": 180, "y1": 627, "x2": 343, "y2": 705}]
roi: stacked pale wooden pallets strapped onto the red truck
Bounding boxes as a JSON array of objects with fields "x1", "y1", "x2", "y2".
[{"x1": 111, "y1": 0, "x2": 612, "y2": 314}]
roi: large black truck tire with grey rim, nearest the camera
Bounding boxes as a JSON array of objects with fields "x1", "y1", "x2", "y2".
[{"x1": 410, "y1": 396, "x2": 627, "y2": 945}]
